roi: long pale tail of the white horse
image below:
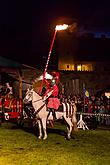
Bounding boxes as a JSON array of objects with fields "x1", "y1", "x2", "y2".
[{"x1": 72, "y1": 103, "x2": 78, "y2": 134}]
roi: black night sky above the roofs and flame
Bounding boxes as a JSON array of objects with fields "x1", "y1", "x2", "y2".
[{"x1": 0, "y1": 0, "x2": 110, "y2": 65}]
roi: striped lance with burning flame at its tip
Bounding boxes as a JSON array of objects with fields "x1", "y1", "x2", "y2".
[{"x1": 39, "y1": 24, "x2": 68, "y2": 94}]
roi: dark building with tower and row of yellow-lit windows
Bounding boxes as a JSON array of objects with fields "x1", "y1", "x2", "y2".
[{"x1": 58, "y1": 33, "x2": 110, "y2": 95}]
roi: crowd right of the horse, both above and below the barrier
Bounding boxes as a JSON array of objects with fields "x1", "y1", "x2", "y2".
[{"x1": 60, "y1": 95, "x2": 110, "y2": 125}]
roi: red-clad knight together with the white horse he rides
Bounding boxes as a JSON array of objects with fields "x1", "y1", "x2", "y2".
[{"x1": 23, "y1": 73, "x2": 77, "y2": 139}]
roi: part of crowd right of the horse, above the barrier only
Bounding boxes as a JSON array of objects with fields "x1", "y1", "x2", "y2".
[{"x1": 60, "y1": 95, "x2": 110, "y2": 114}]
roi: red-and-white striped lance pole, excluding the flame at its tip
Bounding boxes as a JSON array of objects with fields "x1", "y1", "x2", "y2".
[{"x1": 39, "y1": 29, "x2": 57, "y2": 94}]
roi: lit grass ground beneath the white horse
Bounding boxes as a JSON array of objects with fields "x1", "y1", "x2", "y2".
[{"x1": 0, "y1": 123, "x2": 110, "y2": 165}]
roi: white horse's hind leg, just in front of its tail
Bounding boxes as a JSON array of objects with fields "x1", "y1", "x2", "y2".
[{"x1": 64, "y1": 116, "x2": 73, "y2": 139}]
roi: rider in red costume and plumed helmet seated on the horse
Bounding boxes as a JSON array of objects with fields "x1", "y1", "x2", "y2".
[{"x1": 44, "y1": 72, "x2": 60, "y2": 119}]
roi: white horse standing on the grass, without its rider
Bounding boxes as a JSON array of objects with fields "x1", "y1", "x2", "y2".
[{"x1": 23, "y1": 89, "x2": 76, "y2": 140}]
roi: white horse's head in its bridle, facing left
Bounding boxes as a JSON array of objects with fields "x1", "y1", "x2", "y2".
[{"x1": 23, "y1": 89, "x2": 33, "y2": 104}]
